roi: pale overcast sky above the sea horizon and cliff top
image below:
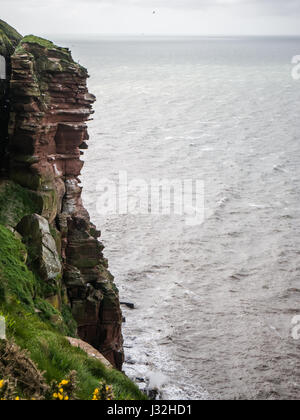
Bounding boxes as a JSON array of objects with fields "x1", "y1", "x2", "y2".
[{"x1": 0, "y1": 0, "x2": 300, "y2": 35}]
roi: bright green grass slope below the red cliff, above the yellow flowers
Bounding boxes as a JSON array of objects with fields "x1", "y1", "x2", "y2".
[{"x1": 0, "y1": 225, "x2": 146, "y2": 400}]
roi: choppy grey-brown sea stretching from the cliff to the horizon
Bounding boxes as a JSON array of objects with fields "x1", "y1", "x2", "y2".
[{"x1": 54, "y1": 37, "x2": 300, "y2": 399}]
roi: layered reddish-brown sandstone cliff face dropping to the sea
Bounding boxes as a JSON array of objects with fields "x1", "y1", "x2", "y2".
[{"x1": 1, "y1": 27, "x2": 123, "y2": 369}]
